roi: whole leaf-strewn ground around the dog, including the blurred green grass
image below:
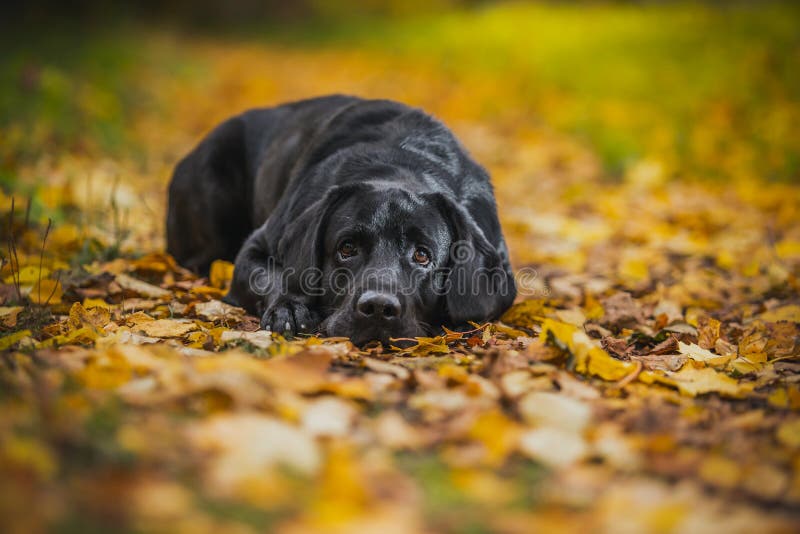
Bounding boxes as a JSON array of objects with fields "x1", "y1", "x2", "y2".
[{"x1": 0, "y1": 5, "x2": 800, "y2": 533}]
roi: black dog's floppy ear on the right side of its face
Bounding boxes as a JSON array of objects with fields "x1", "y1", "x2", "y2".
[{"x1": 432, "y1": 193, "x2": 517, "y2": 325}]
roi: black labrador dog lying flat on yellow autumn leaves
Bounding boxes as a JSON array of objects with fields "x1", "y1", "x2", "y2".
[{"x1": 167, "y1": 95, "x2": 516, "y2": 344}]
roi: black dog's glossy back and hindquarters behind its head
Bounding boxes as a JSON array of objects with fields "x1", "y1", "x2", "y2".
[{"x1": 167, "y1": 95, "x2": 493, "y2": 274}]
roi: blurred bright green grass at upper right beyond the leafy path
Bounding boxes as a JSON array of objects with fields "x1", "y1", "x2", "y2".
[{"x1": 282, "y1": 2, "x2": 800, "y2": 180}]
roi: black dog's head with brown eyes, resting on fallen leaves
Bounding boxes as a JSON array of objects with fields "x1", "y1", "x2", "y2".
[{"x1": 280, "y1": 182, "x2": 516, "y2": 344}]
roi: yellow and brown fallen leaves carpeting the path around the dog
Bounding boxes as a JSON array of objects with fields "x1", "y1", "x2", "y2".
[{"x1": 0, "y1": 9, "x2": 800, "y2": 532}]
